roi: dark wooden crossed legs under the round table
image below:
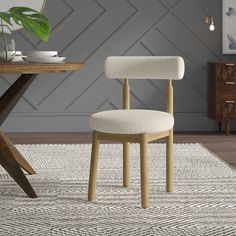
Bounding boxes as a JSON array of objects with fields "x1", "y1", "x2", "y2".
[{"x1": 0, "y1": 74, "x2": 37, "y2": 195}]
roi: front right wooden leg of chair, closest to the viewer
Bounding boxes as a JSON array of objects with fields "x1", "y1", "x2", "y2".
[{"x1": 140, "y1": 134, "x2": 149, "y2": 208}]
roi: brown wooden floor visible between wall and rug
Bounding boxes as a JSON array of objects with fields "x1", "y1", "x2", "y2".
[{"x1": 8, "y1": 133, "x2": 236, "y2": 168}]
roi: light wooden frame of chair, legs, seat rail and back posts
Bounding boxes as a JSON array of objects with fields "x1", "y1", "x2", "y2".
[{"x1": 88, "y1": 79, "x2": 173, "y2": 208}]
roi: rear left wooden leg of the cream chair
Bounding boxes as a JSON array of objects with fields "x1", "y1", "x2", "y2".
[{"x1": 123, "y1": 142, "x2": 130, "y2": 187}]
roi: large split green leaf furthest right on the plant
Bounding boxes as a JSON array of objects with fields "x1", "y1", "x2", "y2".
[{"x1": 9, "y1": 7, "x2": 51, "y2": 41}]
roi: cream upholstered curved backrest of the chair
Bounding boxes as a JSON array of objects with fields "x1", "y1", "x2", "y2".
[{"x1": 105, "y1": 56, "x2": 185, "y2": 80}]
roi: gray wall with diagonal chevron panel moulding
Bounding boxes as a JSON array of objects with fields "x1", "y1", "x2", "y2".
[{"x1": 0, "y1": 0, "x2": 236, "y2": 132}]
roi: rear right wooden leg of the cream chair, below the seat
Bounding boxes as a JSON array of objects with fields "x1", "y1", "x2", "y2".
[{"x1": 166, "y1": 129, "x2": 174, "y2": 192}]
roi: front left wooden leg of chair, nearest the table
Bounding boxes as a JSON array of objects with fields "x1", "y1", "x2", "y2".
[{"x1": 88, "y1": 131, "x2": 99, "y2": 201}]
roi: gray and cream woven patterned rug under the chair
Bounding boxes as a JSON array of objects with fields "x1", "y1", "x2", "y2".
[{"x1": 0, "y1": 144, "x2": 236, "y2": 236}]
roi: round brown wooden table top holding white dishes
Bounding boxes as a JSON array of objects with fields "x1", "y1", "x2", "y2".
[{"x1": 0, "y1": 62, "x2": 84, "y2": 74}]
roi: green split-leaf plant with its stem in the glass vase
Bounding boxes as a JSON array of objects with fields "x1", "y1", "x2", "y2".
[{"x1": 0, "y1": 7, "x2": 51, "y2": 61}]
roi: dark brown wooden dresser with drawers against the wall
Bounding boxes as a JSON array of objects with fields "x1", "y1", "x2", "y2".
[{"x1": 207, "y1": 62, "x2": 236, "y2": 135}]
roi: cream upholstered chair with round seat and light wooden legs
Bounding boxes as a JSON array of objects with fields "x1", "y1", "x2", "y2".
[{"x1": 88, "y1": 56, "x2": 185, "y2": 208}]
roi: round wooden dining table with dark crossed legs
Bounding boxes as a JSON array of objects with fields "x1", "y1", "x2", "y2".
[{"x1": 0, "y1": 63, "x2": 84, "y2": 198}]
